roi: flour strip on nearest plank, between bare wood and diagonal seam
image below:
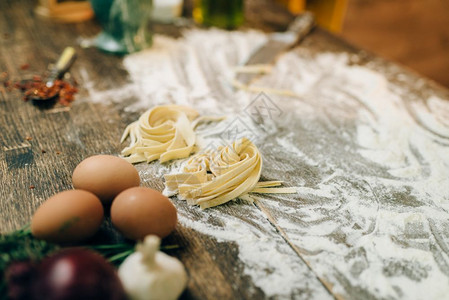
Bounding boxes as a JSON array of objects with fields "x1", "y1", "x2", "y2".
[{"x1": 179, "y1": 206, "x2": 332, "y2": 299}]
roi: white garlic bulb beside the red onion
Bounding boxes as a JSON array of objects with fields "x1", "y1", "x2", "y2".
[{"x1": 118, "y1": 235, "x2": 187, "y2": 300}]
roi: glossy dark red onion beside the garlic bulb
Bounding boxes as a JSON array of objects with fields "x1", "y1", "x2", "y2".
[{"x1": 33, "y1": 248, "x2": 126, "y2": 300}]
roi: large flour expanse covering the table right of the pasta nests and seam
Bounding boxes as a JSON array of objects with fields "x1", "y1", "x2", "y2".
[{"x1": 256, "y1": 51, "x2": 449, "y2": 299}]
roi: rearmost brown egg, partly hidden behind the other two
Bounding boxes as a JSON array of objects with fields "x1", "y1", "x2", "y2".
[{"x1": 72, "y1": 155, "x2": 140, "y2": 204}]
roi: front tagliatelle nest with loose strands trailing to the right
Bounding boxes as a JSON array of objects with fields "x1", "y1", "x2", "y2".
[{"x1": 164, "y1": 138, "x2": 296, "y2": 209}]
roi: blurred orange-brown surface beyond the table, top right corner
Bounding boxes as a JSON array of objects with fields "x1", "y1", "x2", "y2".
[{"x1": 340, "y1": 0, "x2": 449, "y2": 87}]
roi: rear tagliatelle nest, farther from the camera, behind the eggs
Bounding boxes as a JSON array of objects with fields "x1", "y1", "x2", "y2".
[{"x1": 121, "y1": 105, "x2": 198, "y2": 163}]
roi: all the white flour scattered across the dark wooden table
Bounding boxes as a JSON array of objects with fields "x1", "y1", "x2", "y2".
[{"x1": 84, "y1": 30, "x2": 449, "y2": 299}]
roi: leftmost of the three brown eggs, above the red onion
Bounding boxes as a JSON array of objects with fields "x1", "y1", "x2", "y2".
[{"x1": 31, "y1": 190, "x2": 103, "y2": 243}]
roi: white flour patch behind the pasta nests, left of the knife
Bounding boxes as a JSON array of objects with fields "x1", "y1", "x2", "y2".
[{"x1": 85, "y1": 29, "x2": 266, "y2": 114}]
